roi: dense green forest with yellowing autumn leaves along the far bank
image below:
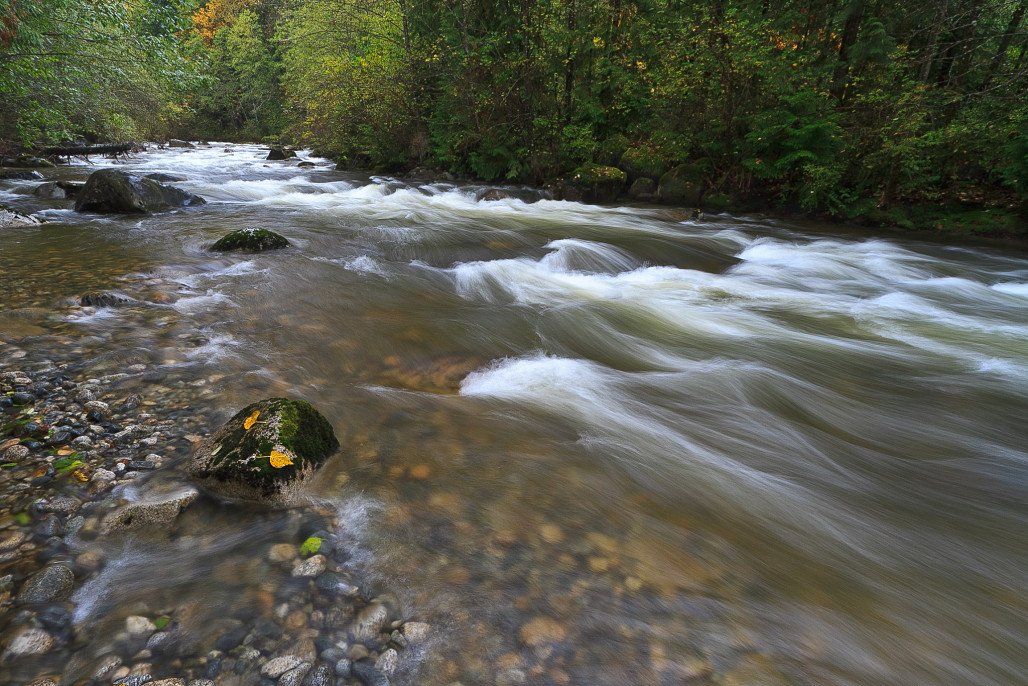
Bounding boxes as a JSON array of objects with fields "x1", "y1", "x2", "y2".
[{"x1": 0, "y1": 0, "x2": 1028, "y2": 236}]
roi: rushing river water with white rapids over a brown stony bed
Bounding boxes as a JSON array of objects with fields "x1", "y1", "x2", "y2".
[{"x1": 0, "y1": 144, "x2": 1028, "y2": 685}]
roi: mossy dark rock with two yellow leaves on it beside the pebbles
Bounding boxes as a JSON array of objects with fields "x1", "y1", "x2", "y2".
[{"x1": 189, "y1": 398, "x2": 339, "y2": 502}]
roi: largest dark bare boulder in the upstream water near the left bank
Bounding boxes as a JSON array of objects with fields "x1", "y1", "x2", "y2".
[{"x1": 75, "y1": 169, "x2": 206, "y2": 214}]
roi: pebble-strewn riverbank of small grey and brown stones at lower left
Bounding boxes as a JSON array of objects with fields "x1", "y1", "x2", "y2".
[{"x1": 0, "y1": 347, "x2": 431, "y2": 686}]
